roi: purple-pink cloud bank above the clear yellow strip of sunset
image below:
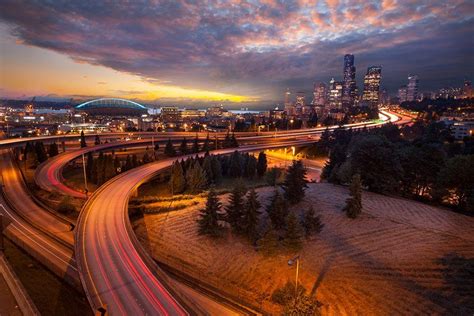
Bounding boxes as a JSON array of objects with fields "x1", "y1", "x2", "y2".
[{"x1": 0, "y1": 0, "x2": 474, "y2": 100}]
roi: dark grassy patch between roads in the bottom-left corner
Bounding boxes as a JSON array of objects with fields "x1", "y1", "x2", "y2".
[{"x1": 5, "y1": 240, "x2": 92, "y2": 316}]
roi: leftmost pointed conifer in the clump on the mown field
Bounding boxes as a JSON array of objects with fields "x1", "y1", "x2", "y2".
[{"x1": 197, "y1": 188, "x2": 222, "y2": 237}]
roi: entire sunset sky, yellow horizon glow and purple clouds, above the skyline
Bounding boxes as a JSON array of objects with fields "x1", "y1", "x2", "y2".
[{"x1": 0, "y1": 0, "x2": 474, "y2": 107}]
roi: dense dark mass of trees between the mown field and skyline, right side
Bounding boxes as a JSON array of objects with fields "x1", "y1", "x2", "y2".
[{"x1": 313, "y1": 122, "x2": 474, "y2": 212}]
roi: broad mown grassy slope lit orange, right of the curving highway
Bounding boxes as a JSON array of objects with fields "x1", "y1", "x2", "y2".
[{"x1": 134, "y1": 183, "x2": 474, "y2": 315}]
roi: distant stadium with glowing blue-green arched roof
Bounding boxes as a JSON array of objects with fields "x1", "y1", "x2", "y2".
[{"x1": 75, "y1": 98, "x2": 148, "y2": 116}]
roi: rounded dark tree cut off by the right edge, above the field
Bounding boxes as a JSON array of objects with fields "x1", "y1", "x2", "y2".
[{"x1": 438, "y1": 155, "x2": 474, "y2": 212}]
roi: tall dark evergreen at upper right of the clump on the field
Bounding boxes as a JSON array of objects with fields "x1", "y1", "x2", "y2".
[{"x1": 283, "y1": 160, "x2": 308, "y2": 204}]
